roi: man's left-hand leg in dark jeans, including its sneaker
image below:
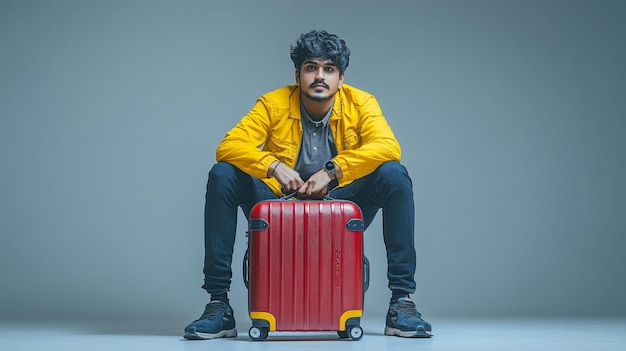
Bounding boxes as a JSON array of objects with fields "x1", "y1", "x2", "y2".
[{"x1": 184, "y1": 162, "x2": 276, "y2": 339}]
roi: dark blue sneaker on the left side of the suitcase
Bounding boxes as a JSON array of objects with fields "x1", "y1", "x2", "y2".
[{"x1": 183, "y1": 300, "x2": 237, "y2": 340}]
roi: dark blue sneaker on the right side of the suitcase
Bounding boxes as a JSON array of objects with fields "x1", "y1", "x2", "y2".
[{"x1": 385, "y1": 297, "x2": 433, "y2": 338}]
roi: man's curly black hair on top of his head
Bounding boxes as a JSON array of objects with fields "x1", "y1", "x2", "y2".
[{"x1": 291, "y1": 29, "x2": 350, "y2": 73}]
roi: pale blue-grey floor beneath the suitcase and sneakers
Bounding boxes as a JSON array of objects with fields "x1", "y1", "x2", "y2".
[{"x1": 0, "y1": 319, "x2": 626, "y2": 351}]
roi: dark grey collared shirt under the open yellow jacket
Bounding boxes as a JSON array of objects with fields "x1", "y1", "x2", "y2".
[{"x1": 294, "y1": 105, "x2": 337, "y2": 181}]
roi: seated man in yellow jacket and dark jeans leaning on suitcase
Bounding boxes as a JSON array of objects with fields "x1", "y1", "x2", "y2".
[{"x1": 184, "y1": 30, "x2": 431, "y2": 339}]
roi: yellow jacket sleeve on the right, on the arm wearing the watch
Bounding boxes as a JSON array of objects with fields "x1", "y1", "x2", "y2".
[{"x1": 334, "y1": 95, "x2": 401, "y2": 186}]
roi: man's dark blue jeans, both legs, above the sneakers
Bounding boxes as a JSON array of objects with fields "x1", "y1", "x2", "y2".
[{"x1": 202, "y1": 161, "x2": 416, "y2": 294}]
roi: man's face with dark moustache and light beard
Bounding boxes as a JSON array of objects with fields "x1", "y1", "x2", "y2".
[{"x1": 296, "y1": 58, "x2": 344, "y2": 102}]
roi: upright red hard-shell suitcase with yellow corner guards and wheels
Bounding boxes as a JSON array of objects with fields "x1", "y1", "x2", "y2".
[{"x1": 243, "y1": 198, "x2": 369, "y2": 340}]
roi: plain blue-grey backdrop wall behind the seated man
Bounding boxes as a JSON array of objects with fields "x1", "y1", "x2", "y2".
[{"x1": 0, "y1": 0, "x2": 626, "y2": 331}]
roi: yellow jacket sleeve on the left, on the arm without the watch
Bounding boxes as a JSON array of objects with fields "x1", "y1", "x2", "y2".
[{"x1": 215, "y1": 97, "x2": 277, "y2": 178}]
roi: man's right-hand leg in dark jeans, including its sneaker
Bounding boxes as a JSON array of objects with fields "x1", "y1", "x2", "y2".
[{"x1": 329, "y1": 162, "x2": 431, "y2": 337}]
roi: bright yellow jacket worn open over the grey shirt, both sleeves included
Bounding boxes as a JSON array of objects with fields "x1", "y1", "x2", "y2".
[{"x1": 215, "y1": 84, "x2": 401, "y2": 195}]
